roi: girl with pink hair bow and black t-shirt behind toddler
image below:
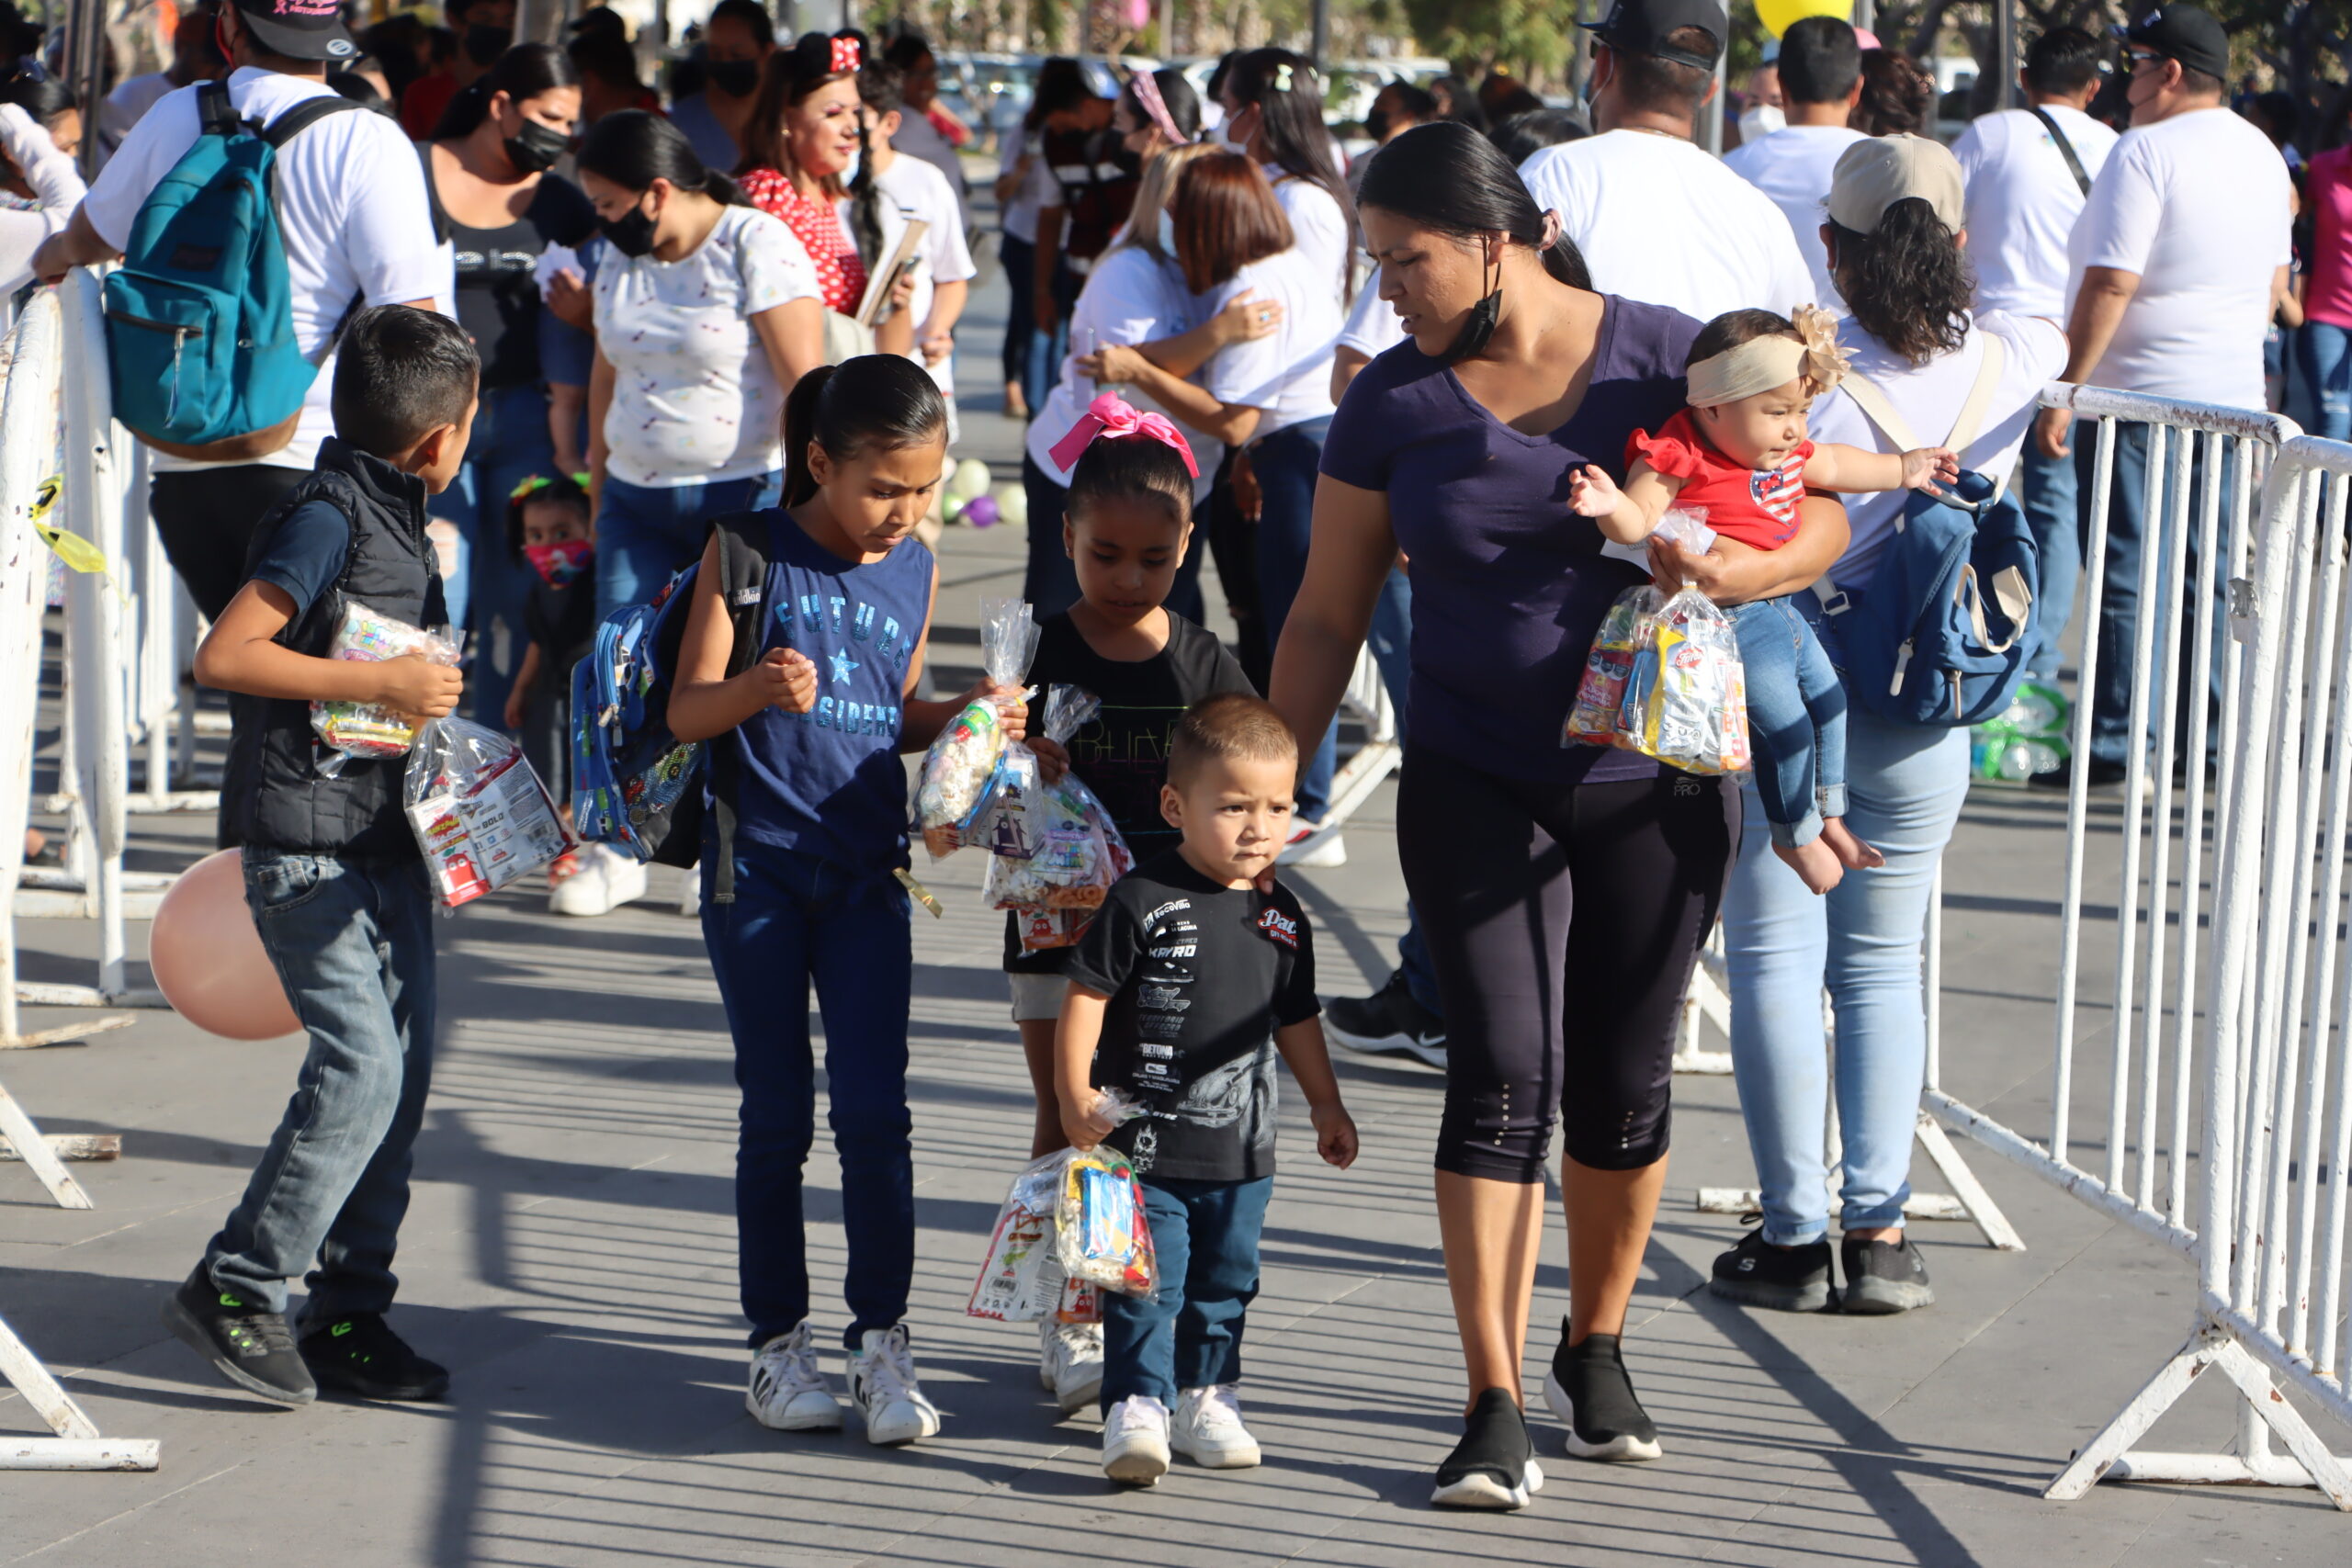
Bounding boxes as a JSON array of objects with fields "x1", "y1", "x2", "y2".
[{"x1": 1011, "y1": 389, "x2": 1256, "y2": 1416}]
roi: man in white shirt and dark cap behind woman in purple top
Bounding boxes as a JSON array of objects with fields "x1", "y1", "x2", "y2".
[{"x1": 1520, "y1": 0, "x2": 1814, "y2": 322}]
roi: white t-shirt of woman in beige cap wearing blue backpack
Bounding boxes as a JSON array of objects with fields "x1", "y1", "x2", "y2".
[{"x1": 1806, "y1": 315, "x2": 2067, "y2": 588}]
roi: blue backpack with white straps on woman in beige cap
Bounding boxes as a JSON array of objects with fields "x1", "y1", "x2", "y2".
[{"x1": 1826, "y1": 333, "x2": 2041, "y2": 728}]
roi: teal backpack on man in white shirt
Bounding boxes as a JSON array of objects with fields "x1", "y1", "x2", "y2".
[{"x1": 106, "y1": 83, "x2": 360, "y2": 458}]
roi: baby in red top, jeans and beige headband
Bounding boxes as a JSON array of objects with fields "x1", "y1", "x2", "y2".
[{"x1": 1569, "y1": 306, "x2": 1959, "y2": 894}]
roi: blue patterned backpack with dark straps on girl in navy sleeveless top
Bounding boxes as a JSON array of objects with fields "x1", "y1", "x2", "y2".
[{"x1": 571, "y1": 513, "x2": 769, "y2": 903}]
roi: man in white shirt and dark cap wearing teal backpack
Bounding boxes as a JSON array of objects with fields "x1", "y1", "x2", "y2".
[{"x1": 33, "y1": 0, "x2": 449, "y2": 618}]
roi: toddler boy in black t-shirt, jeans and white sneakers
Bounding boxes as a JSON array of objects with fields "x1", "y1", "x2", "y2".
[{"x1": 1056, "y1": 694, "x2": 1357, "y2": 1485}]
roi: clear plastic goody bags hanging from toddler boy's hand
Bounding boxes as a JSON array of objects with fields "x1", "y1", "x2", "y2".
[{"x1": 965, "y1": 1090, "x2": 1159, "y2": 1324}]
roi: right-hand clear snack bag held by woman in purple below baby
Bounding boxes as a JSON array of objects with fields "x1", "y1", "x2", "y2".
[{"x1": 1616, "y1": 588, "x2": 1752, "y2": 773}]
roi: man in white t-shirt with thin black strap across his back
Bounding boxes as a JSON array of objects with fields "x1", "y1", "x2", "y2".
[{"x1": 1952, "y1": 28, "x2": 2114, "y2": 680}]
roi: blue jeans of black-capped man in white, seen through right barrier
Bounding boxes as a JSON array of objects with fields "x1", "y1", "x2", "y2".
[{"x1": 2088, "y1": 423, "x2": 2234, "y2": 771}]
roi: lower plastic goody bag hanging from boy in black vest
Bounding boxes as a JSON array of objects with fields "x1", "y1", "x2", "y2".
[{"x1": 407, "y1": 719, "x2": 574, "y2": 909}]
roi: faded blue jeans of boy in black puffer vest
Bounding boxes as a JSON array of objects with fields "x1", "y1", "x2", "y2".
[{"x1": 205, "y1": 849, "x2": 433, "y2": 1324}]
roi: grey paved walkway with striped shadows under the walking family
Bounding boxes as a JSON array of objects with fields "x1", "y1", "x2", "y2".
[{"x1": 0, "y1": 251, "x2": 2352, "y2": 1568}]
